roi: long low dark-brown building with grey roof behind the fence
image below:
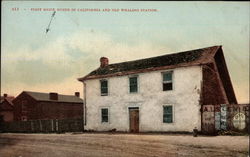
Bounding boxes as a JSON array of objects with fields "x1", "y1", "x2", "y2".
[{"x1": 13, "y1": 91, "x2": 83, "y2": 121}]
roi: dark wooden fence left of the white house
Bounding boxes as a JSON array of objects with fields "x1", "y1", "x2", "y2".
[{"x1": 0, "y1": 119, "x2": 84, "y2": 133}]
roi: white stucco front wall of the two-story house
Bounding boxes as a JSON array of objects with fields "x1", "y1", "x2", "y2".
[{"x1": 85, "y1": 66, "x2": 202, "y2": 132}]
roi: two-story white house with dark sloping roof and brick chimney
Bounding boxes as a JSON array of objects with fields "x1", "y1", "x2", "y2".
[{"x1": 78, "y1": 46, "x2": 237, "y2": 132}]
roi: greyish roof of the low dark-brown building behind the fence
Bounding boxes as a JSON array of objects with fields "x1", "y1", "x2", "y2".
[{"x1": 23, "y1": 91, "x2": 83, "y2": 103}]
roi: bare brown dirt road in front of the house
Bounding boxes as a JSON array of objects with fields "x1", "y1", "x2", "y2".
[{"x1": 0, "y1": 133, "x2": 249, "y2": 157}]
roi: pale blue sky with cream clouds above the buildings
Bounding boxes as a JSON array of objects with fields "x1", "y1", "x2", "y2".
[{"x1": 1, "y1": 1, "x2": 250, "y2": 103}]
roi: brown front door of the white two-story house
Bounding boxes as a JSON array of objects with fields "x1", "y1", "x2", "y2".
[{"x1": 129, "y1": 107, "x2": 139, "y2": 133}]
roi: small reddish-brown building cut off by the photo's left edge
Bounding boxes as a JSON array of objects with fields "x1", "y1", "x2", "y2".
[{"x1": 0, "y1": 94, "x2": 14, "y2": 122}]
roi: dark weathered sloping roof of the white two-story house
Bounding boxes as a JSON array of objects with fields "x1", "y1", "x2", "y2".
[{"x1": 78, "y1": 46, "x2": 221, "y2": 81}]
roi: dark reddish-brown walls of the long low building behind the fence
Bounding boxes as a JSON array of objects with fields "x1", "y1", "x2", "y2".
[{"x1": 13, "y1": 94, "x2": 83, "y2": 121}]
